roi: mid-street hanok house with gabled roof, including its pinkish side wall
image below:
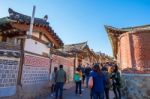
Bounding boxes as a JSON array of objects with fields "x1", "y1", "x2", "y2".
[{"x1": 51, "y1": 42, "x2": 98, "y2": 82}]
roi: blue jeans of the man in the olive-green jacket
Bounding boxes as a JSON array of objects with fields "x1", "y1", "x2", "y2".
[{"x1": 55, "y1": 82, "x2": 64, "y2": 99}]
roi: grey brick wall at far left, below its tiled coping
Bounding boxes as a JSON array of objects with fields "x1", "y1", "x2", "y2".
[{"x1": 0, "y1": 57, "x2": 19, "y2": 97}]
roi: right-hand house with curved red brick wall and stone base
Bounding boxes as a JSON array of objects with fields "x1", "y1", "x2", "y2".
[{"x1": 105, "y1": 25, "x2": 150, "y2": 99}]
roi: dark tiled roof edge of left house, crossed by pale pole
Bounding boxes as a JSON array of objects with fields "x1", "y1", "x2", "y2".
[{"x1": 0, "y1": 8, "x2": 64, "y2": 46}]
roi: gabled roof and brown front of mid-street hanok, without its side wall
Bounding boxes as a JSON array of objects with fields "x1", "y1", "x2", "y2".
[{"x1": 60, "y1": 42, "x2": 95, "y2": 67}]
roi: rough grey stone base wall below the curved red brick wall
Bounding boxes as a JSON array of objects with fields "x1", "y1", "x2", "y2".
[{"x1": 122, "y1": 74, "x2": 150, "y2": 99}]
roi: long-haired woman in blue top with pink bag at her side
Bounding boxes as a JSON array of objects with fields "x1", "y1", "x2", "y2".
[{"x1": 89, "y1": 64, "x2": 106, "y2": 99}]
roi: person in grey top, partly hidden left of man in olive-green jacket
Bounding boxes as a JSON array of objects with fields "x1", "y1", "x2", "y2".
[{"x1": 51, "y1": 67, "x2": 57, "y2": 96}]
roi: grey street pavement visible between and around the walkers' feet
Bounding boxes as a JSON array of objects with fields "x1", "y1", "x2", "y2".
[{"x1": 37, "y1": 83, "x2": 114, "y2": 99}]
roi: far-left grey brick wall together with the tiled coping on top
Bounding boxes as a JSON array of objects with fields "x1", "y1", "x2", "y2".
[{"x1": 0, "y1": 42, "x2": 20, "y2": 98}]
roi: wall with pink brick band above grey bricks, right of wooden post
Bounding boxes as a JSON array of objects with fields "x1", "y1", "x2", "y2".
[{"x1": 7, "y1": 53, "x2": 50, "y2": 99}]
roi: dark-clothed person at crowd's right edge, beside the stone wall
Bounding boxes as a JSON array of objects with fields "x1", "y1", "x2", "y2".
[{"x1": 111, "y1": 64, "x2": 121, "y2": 99}]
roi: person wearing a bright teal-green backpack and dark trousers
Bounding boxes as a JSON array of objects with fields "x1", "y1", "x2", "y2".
[{"x1": 74, "y1": 68, "x2": 82, "y2": 95}]
